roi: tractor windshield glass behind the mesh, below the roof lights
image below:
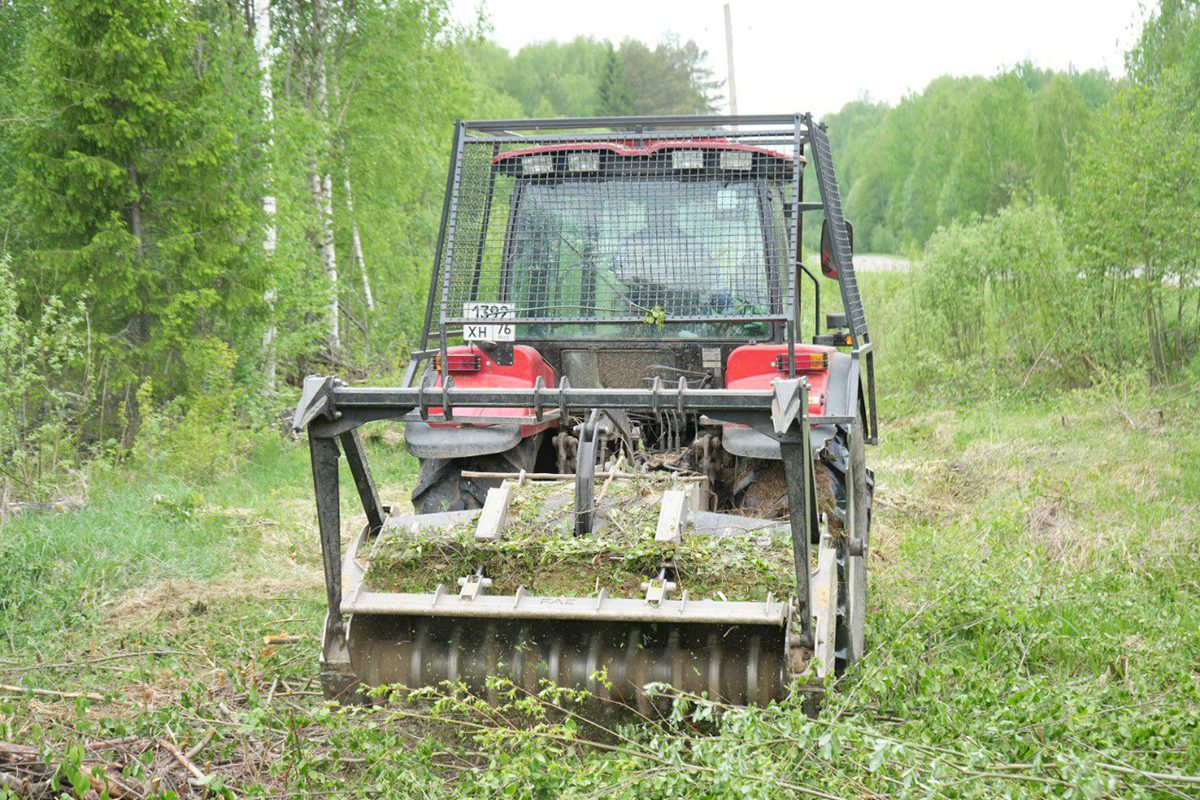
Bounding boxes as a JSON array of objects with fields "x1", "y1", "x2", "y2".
[{"x1": 506, "y1": 179, "x2": 778, "y2": 338}]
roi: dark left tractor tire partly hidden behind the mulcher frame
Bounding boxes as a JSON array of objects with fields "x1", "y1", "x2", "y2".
[{"x1": 413, "y1": 433, "x2": 541, "y2": 513}]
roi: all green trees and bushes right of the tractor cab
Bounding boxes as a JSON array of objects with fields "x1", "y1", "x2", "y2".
[{"x1": 849, "y1": 0, "x2": 1200, "y2": 395}]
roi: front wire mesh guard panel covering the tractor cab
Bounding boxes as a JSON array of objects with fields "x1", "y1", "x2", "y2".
[{"x1": 438, "y1": 121, "x2": 804, "y2": 338}]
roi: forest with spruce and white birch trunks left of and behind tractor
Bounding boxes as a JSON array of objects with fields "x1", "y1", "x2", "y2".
[{"x1": 0, "y1": 0, "x2": 718, "y2": 492}]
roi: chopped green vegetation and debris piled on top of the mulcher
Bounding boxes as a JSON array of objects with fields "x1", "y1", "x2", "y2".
[{"x1": 366, "y1": 475, "x2": 794, "y2": 600}]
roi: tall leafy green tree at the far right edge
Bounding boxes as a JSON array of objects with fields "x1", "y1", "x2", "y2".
[{"x1": 1069, "y1": 0, "x2": 1200, "y2": 378}]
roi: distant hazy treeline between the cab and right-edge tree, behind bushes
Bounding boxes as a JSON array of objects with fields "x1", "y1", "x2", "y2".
[{"x1": 826, "y1": 64, "x2": 1111, "y2": 252}]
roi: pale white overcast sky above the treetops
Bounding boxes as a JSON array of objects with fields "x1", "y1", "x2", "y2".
[{"x1": 452, "y1": 0, "x2": 1142, "y2": 114}]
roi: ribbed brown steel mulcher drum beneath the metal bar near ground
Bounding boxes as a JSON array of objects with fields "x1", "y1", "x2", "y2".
[{"x1": 349, "y1": 614, "x2": 787, "y2": 714}]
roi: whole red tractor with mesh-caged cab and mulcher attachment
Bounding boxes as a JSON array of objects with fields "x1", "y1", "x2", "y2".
[{"x1": 294, "y1": 114, "x2": 877, "y2": 710}]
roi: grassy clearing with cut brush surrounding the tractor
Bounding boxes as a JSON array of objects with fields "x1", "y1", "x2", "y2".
[{"x1": 0, "y1": 277, "x2": 1200, "y2": 800}]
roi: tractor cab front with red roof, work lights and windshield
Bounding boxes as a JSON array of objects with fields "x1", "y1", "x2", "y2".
[{"x1": 494, "y1": 139, "x2": 796, "y2": 341}]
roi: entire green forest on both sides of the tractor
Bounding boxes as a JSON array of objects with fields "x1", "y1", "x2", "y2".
[{"x1": 0, "y1": 0, "x2": 1200, "y2": 501}]
